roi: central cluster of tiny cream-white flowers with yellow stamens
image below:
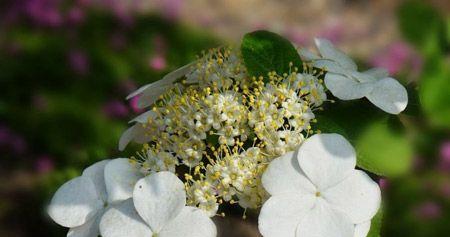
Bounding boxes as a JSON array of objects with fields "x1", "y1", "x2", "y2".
[{"x1": 130, "y1": 48, "x2": 326, "y2": 215}]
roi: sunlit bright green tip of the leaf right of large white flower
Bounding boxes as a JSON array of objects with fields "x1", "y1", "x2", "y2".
[{"x1": 355, "y1": 120, "x2": 413, "y2": 177}]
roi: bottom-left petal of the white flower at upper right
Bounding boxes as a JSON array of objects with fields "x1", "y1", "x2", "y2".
[{"x1": 325, "y1": 73, "x2": 375, "y2": 100}]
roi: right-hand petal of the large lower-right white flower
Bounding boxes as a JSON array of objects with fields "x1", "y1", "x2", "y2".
[{"x1": 323, "y1": 170, "x2": 381, "y2": 224}]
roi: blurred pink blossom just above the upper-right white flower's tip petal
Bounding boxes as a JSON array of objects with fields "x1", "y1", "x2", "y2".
[{"x1": 371, "y1": 42, "x2": 422, "y2": 74}]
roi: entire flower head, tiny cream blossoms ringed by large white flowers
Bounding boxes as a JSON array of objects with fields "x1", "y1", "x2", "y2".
[{"x1": 49, "y1": 32, "x2": 408, "y2": 237}]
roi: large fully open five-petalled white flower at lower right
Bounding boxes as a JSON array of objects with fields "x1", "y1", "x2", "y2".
[{"x1": 259, "y1": 134, "x2": 381, "y2": 237}]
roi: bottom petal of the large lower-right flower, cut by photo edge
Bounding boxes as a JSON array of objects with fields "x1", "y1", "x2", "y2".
[{"x1": 297, "y1": 199, "x2": 355, "y2": 237}]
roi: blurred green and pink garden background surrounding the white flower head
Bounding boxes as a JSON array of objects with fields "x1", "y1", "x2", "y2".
[{"x1": 0, "y1": 0, "x2": 450, "y2": 236}]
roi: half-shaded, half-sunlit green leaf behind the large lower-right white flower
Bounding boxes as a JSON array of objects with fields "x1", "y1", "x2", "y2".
[{"x1": 313, "y1": 100, "x2": 412, "y2": 177}]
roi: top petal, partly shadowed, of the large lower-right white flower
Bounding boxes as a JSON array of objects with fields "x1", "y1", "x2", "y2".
[{"x1": 298, "y1": 133, "x2": 356, "y2": 191}]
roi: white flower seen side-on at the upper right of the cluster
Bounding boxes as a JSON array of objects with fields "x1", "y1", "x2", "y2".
[{"x1": 300, "y1": 39, "x2": 408, "y2": 114}]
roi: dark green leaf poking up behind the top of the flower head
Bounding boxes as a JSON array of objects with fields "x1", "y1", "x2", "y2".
[{"x1": 241, "y1": 31, "x2": 302, "y2": 77}]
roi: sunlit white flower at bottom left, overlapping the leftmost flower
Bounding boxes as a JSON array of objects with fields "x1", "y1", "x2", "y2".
[{"x1": 100, "y1": 171, "x2": 216, "y2": 237}]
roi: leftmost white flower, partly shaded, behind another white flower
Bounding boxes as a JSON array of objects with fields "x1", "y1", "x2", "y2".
[{"x1": 48, "y1": 158, "x2": 142, "y2": 237}]
